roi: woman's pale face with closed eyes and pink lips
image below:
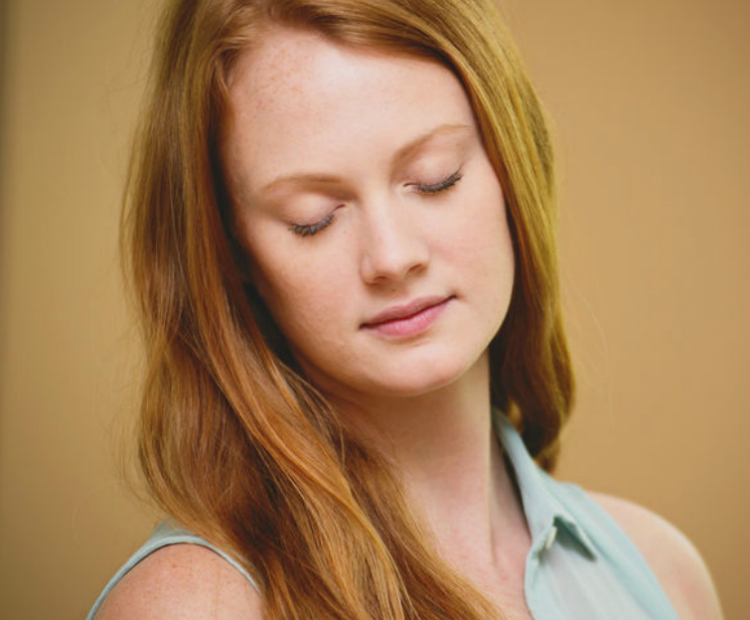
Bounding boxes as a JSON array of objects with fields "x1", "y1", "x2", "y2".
[{"x1": 222, "y1": 29, "x2": 513, "y2": 401}]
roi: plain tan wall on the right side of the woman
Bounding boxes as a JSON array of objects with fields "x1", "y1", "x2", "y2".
[{"x1": 503, "y1": 0, "x2": 750, "y2": 618}]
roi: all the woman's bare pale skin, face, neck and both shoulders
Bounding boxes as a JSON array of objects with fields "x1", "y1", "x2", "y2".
[{"x1": 97, "y1": 29, "x2": 721, "y2": 620}]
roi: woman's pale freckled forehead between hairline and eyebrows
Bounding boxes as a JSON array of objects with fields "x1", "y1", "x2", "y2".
[{"x1": 223, "y1": 28, "x2": 473, "y2": 191}]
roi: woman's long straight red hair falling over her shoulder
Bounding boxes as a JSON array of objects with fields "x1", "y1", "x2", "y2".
[{"x1": 123, "y1": 0, "x2": 573, "y2": 620}]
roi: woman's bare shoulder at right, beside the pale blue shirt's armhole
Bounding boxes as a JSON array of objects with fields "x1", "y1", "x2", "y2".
[{"x1": 589, "y1": 493, "x2": 724, "y2": 620}]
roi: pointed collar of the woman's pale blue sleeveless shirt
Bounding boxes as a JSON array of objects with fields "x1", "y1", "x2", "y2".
[{"x1": 493, "y1": 412, "x2": 598, "y2": 559}]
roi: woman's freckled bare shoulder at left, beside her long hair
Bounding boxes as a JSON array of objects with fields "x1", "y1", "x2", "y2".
[{"x1": 95, "y1": 544, "x2": 262, "y2": 620}]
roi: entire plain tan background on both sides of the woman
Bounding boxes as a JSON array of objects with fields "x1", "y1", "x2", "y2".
[{"x1": 0, "y1": 0, "x2": 750, "y2": 620}]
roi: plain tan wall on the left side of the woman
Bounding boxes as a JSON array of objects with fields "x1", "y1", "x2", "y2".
[{"x1": 0, "y1": 0, "x2": 159, "y2": 620}]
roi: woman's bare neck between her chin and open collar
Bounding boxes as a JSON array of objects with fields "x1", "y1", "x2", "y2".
[{"x1": 326, "y1": 356, "x2": 528, "y2": 580}]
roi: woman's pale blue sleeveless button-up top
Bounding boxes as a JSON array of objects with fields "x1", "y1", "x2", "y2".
[{"x1": 88, "y1": 416, "x2": 679, "y2": 620}]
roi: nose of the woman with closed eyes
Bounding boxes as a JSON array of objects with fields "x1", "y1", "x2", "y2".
[{"x1": 360, "y1": 201, "x2": 430, "y2": 284}]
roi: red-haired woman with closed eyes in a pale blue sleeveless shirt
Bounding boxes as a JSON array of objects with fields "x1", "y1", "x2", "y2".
[{"x1": 86, "y1": 0, "x2": 720, "y2": 620}]
